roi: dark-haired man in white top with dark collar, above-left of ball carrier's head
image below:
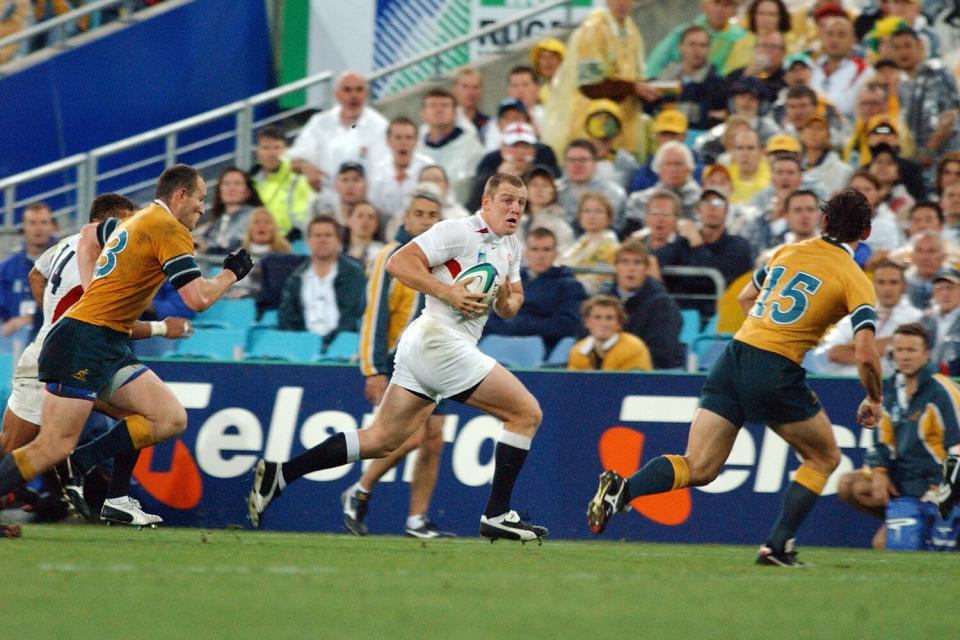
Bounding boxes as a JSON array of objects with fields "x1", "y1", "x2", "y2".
[{"x1": 416, "y1": 88, "x2": 484, "y2": 191}]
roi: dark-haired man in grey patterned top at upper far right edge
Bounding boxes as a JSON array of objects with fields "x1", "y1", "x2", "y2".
[{"x1": 893, "y1": 28, "x2": 960, "y2": 179}]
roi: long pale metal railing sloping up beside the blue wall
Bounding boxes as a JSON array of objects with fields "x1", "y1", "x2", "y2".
[{"x1": 0, "y1": 0, "x2": 574, "y2": 240}]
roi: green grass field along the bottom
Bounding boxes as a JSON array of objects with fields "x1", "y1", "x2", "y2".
[{"x1": 0, "y1": 526, "x2": 960, "y2": 640}]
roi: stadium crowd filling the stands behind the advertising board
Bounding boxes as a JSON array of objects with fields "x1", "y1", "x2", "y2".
[{"x1": 0, "y1": 0, "x2": 960, "y2": 373}]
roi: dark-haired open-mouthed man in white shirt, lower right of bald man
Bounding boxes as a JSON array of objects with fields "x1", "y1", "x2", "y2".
[{"x1": 367, "y1": 116, "x2": 431, "y2": 220}]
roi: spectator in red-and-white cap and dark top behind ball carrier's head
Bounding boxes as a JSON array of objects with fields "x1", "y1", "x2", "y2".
[{"x1": 466, "y1": 122, "x2": 560, "y2": 211}]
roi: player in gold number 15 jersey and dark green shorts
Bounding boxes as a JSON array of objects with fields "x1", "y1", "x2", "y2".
[{"x1": 587, "y1": 189, "x2": 883, "y2": 566}]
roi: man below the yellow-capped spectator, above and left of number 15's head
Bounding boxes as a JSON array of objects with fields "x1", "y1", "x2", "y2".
[{"x1": 743, "y1": 153, "x2": 803, "y2": 254}]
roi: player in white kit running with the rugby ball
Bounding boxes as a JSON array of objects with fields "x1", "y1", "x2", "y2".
[{"x1": 247, "y1": 173, "x2": 547, "y2": 542}]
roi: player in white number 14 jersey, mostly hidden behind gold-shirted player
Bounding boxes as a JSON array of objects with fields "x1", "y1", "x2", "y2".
[{"x1": 0, "y1": 193, "x2": 190, "y2": 525}]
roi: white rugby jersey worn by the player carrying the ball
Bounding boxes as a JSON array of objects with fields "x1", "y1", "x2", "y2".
[{"x1": 412, "y1": 213, "x2": 520, "y2": 342}]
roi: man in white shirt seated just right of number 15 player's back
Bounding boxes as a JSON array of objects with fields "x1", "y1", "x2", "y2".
[{"x1": 805, "y1": 260, "x2": 923, "y2": 376}]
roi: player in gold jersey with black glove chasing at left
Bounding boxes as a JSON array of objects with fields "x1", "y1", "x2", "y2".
[{"x1": 0, "y1": 165, "x2": 253, "y2": 524}]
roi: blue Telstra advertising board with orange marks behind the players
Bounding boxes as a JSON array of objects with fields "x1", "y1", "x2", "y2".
[{"x1": 134, "y1": 361, "x2": 878, "y2": 546}]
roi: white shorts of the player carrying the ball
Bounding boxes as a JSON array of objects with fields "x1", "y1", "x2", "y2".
[{"x1": 390, "y1": 316, "x2": 497, "y2": 402}]
